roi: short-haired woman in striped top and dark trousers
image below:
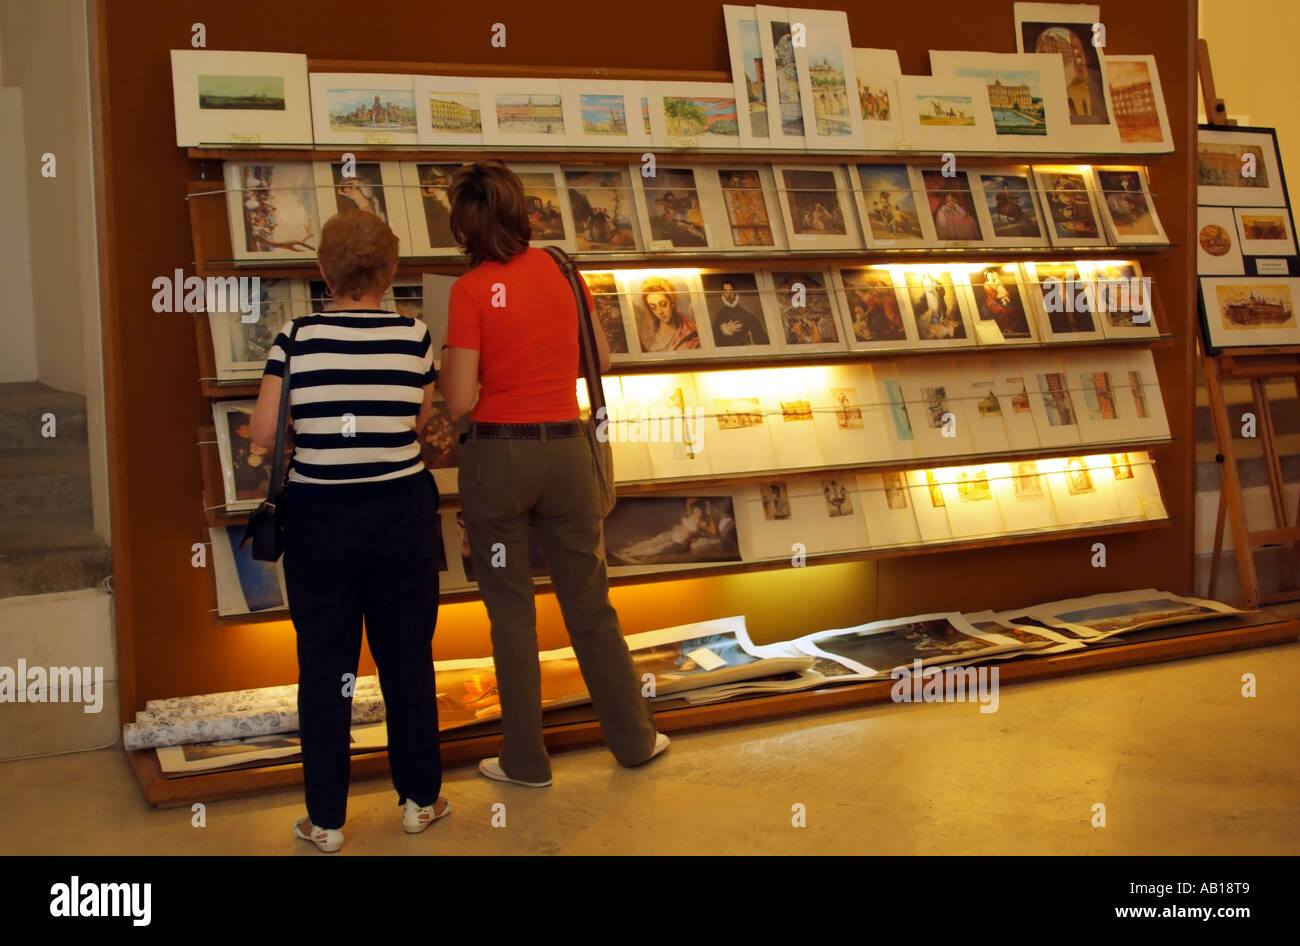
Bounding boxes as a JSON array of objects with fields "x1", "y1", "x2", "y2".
[{"x1": 252, "y1": 211, "x2": 451, "y2": 851}]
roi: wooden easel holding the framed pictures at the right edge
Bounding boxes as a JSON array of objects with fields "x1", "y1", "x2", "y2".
[{"x1": 1196, "y1": 39, "x2": 1300, "y2": 608}]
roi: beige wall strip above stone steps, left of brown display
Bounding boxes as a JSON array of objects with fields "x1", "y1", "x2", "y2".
[{"x1": 0, "y1": 0, "x2": 108, "y2": 538}]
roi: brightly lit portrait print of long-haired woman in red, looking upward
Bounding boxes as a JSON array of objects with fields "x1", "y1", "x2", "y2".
[{"x1": 616, "y1": 269, "x2": 712, "y2": 357}]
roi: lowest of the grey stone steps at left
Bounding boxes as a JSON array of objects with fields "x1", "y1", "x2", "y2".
[{"x1": 0, "y1": 512, "x2": 113, "y2": 598}]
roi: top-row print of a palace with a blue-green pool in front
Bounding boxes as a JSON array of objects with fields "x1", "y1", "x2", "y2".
[{"x1": 930, "y1": 49, "x2": 1075, "y2": 152}]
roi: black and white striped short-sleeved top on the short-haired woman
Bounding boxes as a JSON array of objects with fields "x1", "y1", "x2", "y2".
[{"x1": 265, "y1": 309, "x2": 437, "y2": 486}]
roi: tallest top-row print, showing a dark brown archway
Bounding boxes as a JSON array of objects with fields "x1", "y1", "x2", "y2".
[{"x1": 1015, "y1": 3, "x2": 1110, "y2": 131}]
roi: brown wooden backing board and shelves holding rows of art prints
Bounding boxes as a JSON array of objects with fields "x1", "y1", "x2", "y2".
[{"x1": 91, "y1": 0, "x2": 1300, "y2": 806}]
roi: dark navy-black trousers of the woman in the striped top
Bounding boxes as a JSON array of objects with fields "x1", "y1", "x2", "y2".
[{"x1": 285, "y1": 473, "x2": 442, "y2": 828}]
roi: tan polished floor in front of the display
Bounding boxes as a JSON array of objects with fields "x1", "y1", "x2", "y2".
[{"x1": 0, "y1": 645, "x2": 1300, "y2": 856}]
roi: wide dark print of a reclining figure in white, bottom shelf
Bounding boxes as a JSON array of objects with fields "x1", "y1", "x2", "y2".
[{"x1": 605, "y1": 496, "x2": 740, "y2": 565}]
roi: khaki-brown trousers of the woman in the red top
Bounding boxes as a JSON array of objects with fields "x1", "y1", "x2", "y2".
[{"x1": 460, "y1": 428, "x2": 655, "y2": 782}]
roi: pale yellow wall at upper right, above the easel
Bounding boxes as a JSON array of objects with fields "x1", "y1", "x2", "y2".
[{"x1": 1200, "y1": 0, "x2": 1300, "y2": 192}]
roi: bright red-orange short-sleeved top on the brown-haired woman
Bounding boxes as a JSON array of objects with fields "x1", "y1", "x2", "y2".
[{"x1": 447, "y1": 247, "x2": 592, "y2": 424}]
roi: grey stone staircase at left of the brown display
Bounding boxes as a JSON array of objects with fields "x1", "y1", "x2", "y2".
[{"x1": 0, "y1": 381, "x2": 112, "y2": 598}]
